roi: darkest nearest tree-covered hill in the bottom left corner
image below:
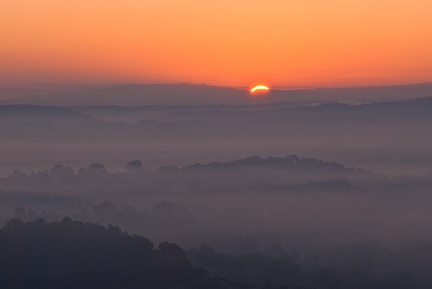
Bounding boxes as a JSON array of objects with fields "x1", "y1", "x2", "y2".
[{"x1": 0, "y1": 218, "x2": 253, "y2": 289}]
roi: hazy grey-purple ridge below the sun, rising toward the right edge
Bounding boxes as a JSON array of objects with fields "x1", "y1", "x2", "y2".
[{"x1": 164, "y1": 97, "x2": 432, "y2": 125}]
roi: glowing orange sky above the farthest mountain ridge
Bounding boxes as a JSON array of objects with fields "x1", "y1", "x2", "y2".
[{"x1": 0, "y1": 0, "x2": 432, "y2": 87}]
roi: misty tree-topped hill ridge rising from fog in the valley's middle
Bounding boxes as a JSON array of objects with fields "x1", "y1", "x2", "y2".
[{"x1": 0, "y1": 155, "x2": 389, "y2": 194}]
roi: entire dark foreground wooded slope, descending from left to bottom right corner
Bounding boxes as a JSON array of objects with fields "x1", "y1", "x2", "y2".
[{"x1": 0, "y1": 217, "x2": 428, "y2": 289}]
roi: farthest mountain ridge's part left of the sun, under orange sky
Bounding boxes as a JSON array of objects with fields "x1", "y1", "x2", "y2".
[{"x1": 0, "y1": 83, "x2": 248, "y2": 106}]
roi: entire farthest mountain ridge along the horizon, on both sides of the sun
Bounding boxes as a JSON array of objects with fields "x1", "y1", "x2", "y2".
[{"x1": 0, "y1": 83, "x2": 432, "y2": 106}]
